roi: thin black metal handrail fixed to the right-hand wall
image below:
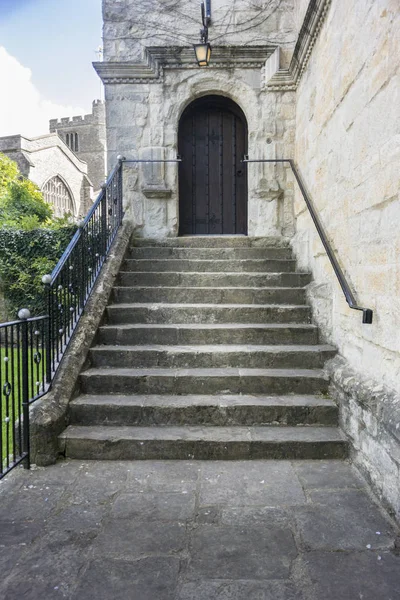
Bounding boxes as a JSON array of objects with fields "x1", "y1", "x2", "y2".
[{"x1": 241, "y1": 155, "x2": 373, "y2": 325}]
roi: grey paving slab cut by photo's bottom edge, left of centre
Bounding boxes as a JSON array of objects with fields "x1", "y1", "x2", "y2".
[{"x1": 73, "y1": 556, "x2": 179, "y2": 600}]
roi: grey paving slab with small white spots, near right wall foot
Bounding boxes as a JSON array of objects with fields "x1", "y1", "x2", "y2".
[{"x1": 293, "y1": 490, "x2": 397, "y2": 551}]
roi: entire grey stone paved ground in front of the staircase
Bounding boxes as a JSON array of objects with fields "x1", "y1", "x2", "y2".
[{"x1": 0, "y1": 461, "x2": 400, "y2": 600}]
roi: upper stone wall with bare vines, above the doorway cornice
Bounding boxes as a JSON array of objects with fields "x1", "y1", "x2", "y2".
[{"x1": 103, "y1": 0, "x2": 296, "y2": 62}]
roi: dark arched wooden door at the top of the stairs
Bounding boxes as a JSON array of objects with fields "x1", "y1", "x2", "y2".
[{"x1": 178, "y1": 96, "x2": 247, "y2": 235}]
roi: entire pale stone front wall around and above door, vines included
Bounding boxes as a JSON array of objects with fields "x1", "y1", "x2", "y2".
[{"x1": 99, "y1": 0, "x2": 297, "y2": 237}]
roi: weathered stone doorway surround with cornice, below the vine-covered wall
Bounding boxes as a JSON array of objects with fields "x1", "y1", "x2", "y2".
[{"x1": 95, "y1": 46, "x2": 295, "y2": 238}]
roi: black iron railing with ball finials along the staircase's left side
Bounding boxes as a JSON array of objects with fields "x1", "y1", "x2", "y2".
[{"x1": 0, "y1": 157, "x2": 124, "y2": 479}]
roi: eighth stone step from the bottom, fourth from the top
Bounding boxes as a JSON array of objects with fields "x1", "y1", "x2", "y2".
[{"x1": 117, "y1": 271, "x2": 311, "y2": 288}]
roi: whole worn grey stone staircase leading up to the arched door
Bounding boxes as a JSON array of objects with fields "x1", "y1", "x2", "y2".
[{"x1": 59, "y1": 236, "x2": 348, "y2": 459}]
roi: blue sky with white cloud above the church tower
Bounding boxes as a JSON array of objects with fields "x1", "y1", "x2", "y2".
[{"x1": 0, "y1": 0, "x2": 102, "y2": 137}]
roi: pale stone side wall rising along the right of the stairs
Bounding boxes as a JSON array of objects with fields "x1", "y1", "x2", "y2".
[{"x1": 293, "y1": 0, "x2": 400, "y2": 511}]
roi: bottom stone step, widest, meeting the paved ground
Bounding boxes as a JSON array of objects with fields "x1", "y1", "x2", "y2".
[{"x1": 59, "y1": 425, "x2": 348, "y2": 460}]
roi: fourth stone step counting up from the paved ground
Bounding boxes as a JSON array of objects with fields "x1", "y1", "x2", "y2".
[{"x1": 90, "y1": 345, "x2": 336, "y2": 369}]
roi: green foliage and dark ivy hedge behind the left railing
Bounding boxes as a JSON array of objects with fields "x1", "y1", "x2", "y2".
[{"x1": 0, "y1": 153, "x2": 77, "y2": 319}]
